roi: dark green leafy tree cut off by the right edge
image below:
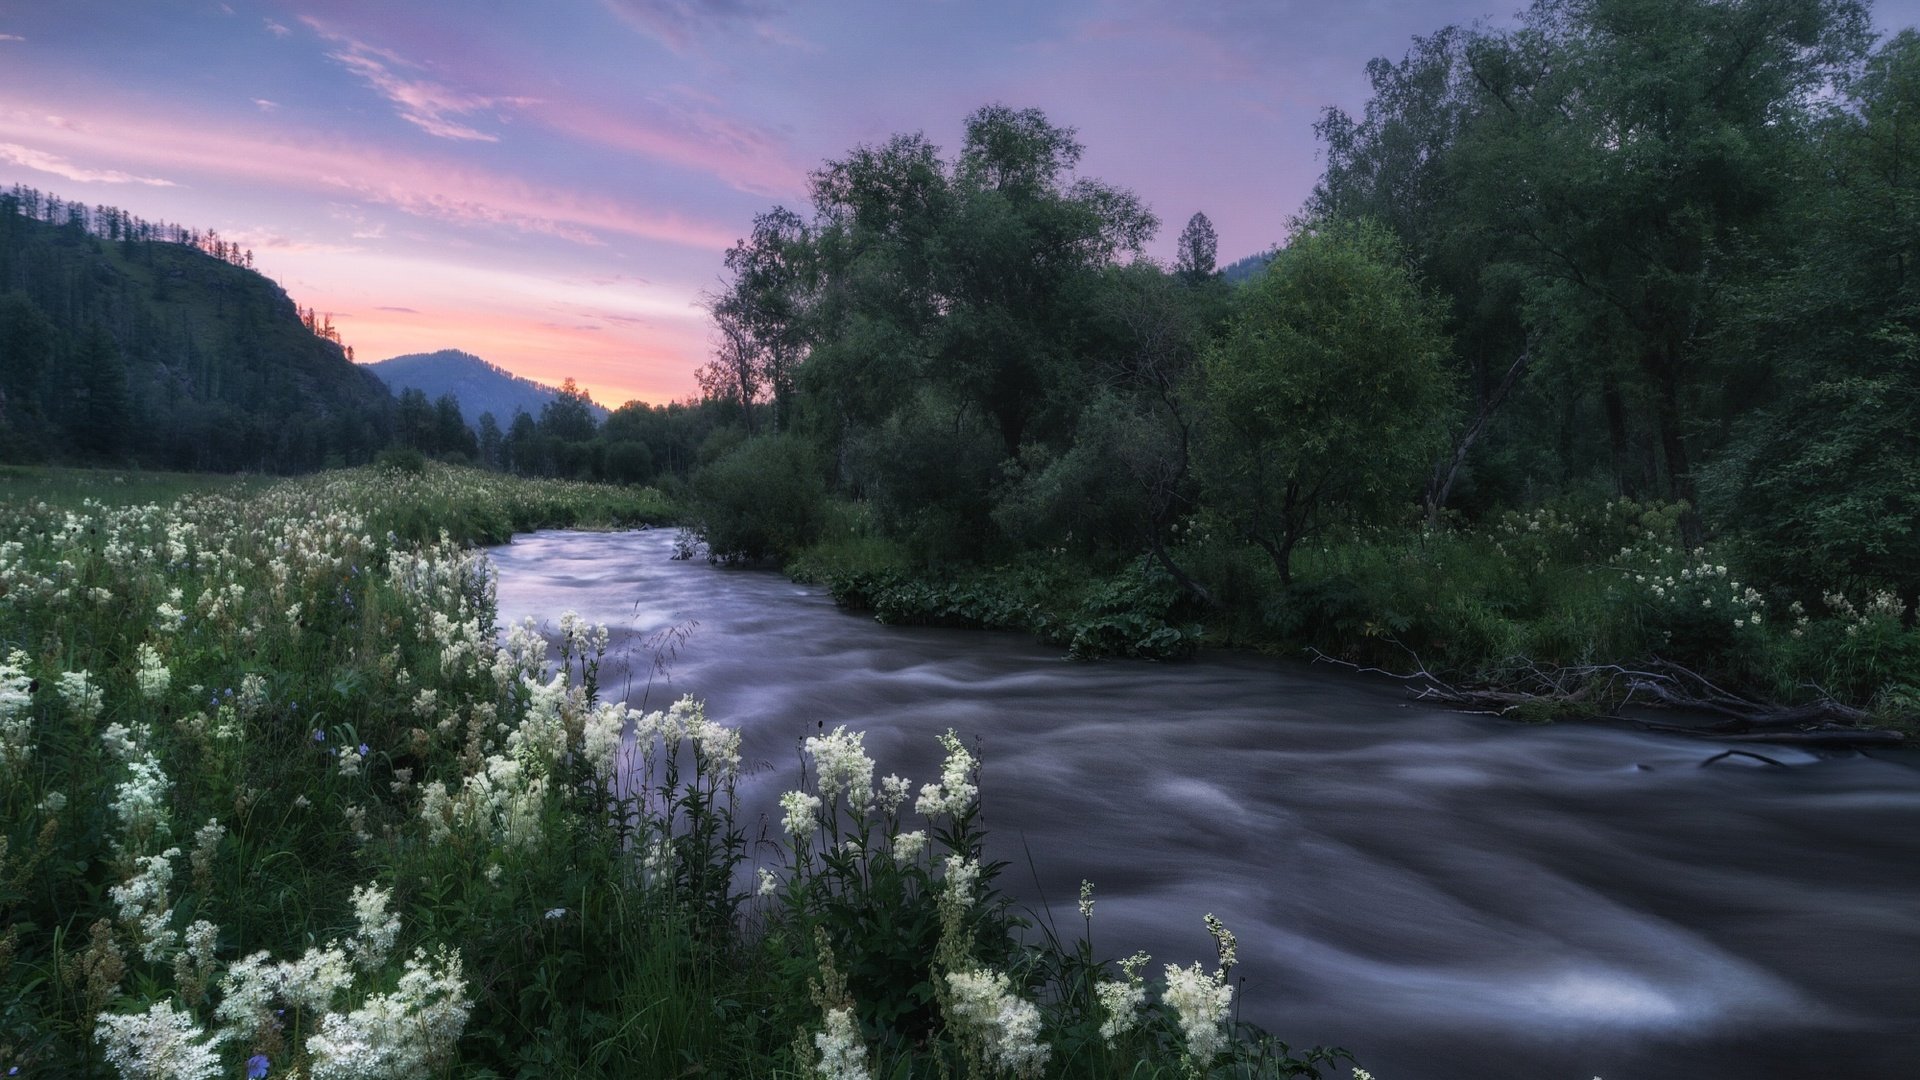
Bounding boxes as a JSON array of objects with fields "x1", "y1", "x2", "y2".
[{"x1": 1701, "y1": 31, "x2": 1920, "y2": 603}]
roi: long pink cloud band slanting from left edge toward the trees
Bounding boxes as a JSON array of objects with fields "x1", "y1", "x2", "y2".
[{"x1": 0, "y1": 101, "x2": 735, "y2": 252}]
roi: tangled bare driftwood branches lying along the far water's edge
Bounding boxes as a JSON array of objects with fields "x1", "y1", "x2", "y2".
[{"x1": 1308, "y1": 650, "x2": 1907, "y2": 749}]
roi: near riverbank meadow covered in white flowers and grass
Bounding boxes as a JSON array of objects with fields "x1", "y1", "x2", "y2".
[{"x1": 0, "y1": 465, "x2": 1338, "y2": 1078}]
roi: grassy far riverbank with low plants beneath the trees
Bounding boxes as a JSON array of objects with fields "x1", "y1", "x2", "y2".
[{"x1": 787, "y1": 500, "x2": 1920, "y2": 730}]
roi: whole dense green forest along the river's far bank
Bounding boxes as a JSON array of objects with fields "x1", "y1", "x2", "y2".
[{"x1": 675, "y1": 0, "x2": 1920, "y2": 719}]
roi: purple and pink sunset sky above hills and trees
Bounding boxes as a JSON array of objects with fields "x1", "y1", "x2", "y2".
[{"x1": 0, "y1": 0, "x2": 1920, "y2": 405}]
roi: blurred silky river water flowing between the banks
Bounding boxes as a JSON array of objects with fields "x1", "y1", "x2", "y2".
[{"x1": 492, "y1": 530, "x2": 1920, "y2": 1080}]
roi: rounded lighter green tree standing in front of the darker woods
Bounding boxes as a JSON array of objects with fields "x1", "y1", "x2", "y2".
[{"x1": 1196, "y1": 223, "x2": 1455, "y2": 584}]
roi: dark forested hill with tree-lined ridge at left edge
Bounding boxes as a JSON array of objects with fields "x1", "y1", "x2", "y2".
[{"x1": 0, "y1": 186, "x2": 394, "y2": 473}]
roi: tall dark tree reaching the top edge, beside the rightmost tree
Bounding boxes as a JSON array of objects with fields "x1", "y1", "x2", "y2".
[{"x1": 1443, "y1": 0, "x2": 1868, "y2": 500}]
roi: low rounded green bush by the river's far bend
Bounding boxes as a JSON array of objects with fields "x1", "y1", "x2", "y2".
[{"x1": 693, "y1": 434, "x2": 826, "y2": 561}]
